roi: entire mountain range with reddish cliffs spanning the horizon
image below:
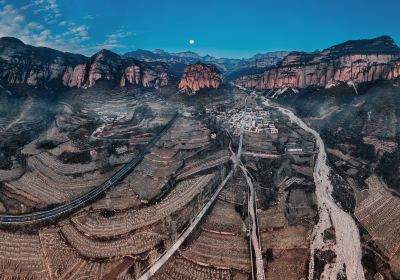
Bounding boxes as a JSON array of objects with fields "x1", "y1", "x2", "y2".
[{"x1": 0, "y1": 36, "x2": 400, "y2": 91}]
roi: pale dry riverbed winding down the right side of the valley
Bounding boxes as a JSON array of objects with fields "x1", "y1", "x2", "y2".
[{"x1": 263, "y1": 98, "x2": 365, "y2": 280}]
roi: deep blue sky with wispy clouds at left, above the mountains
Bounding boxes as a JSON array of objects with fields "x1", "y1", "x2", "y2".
[{"x1": 0, "y1": 0, "x2": 400, "y2": 58}]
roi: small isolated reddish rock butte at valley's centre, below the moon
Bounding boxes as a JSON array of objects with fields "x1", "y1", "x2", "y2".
[{"x1": 178, "y1": 62, "x2": 223, "y2": 93}]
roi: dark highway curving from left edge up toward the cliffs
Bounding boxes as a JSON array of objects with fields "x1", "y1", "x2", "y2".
[{"x1": 0, "y1": 113, "x2": 179, "y2": 225}]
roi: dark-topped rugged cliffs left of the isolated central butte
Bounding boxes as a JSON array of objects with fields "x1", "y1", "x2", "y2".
[{"x1": 0, "y1": 37, "x2": 168, "y2": 88}]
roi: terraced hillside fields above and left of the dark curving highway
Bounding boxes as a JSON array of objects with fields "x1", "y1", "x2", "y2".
[{"x1": 0, "y1": 91, "x2": 174, "y2": 214}]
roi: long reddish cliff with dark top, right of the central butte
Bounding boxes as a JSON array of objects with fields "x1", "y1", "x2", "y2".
[{"x1": 235, "y1": 36, "x2": 400, "y2": 90}]
